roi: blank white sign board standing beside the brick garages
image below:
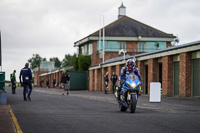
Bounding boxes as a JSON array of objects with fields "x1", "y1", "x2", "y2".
[{"x1": 149, "y1": 82, "x2": 161, "y2": 102}]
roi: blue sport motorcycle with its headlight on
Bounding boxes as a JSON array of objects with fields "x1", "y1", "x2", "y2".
[{"x1": 115, "y1": 73, "x2": 141, "y2": 113}]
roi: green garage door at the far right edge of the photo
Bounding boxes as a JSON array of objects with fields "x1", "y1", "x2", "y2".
[{"x1": 192, "y1": 59, "x2": 200, "y2": 96}]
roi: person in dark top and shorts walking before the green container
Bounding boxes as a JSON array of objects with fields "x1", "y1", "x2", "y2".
[{"x1": 61, "y1": 69, "x2": 70, "y2": 95}]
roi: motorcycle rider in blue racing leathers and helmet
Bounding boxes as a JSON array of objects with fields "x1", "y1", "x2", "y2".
[{"x1": 118, "y1": 59, "x2": 142, "y2": 100}]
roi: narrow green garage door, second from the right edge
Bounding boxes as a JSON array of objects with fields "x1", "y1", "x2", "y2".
[{"x1": 174, "y1": 62, "x2": 179, "y2": 95}]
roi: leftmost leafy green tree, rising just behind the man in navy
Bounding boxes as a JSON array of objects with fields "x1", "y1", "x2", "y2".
[{"x1": 28, "y1": 54, "x2": 42, "y2": 69}]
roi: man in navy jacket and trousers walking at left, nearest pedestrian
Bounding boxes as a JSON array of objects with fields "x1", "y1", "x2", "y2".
[{"x1": 19, "y1": 63, "x2": 32, "y2": 101}]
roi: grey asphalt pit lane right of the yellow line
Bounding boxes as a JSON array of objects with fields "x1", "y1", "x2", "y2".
[{"x1": 6, "y1": 88, "x2": 200, "y2": 133}]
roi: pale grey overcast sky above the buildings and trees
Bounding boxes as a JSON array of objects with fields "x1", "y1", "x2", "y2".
[{"x1": 0, "y1": 0, "x2": 200, "y2": 81}]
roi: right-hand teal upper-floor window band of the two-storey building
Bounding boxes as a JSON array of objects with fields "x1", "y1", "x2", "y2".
[{"x1": 138, "y1": 42, "x2": 167, "y2": 52}]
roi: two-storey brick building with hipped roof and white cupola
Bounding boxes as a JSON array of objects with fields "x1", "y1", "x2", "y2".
[{"x1": 74, "y1": 4, "x2": 175, "y2": 66}]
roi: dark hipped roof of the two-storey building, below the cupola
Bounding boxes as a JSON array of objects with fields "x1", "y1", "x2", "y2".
[{"x1": 74, "y1": 16, "x2": 175, "y2": 46}]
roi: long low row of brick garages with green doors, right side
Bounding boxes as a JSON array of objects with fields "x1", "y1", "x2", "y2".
[{"x1": 89, "y1": 41, "x2": 200, "y2": 97}]
